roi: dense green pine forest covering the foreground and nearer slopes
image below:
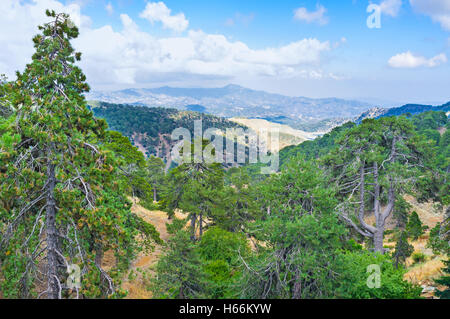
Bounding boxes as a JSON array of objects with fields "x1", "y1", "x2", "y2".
[{"x1": 0, "y1": 11, "x2": 450, "y2": 299}]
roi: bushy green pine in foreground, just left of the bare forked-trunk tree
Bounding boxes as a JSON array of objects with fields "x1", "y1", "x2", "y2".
[{"x1": 239, "y1": 158, "x2": 346, "y2": 298}]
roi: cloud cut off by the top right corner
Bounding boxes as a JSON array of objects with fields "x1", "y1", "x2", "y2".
[{"x1": 409, "y1": 0, "x2": 450, "y2": 31}]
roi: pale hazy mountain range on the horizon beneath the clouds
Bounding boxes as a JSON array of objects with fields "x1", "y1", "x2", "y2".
[{"x1": 87, "y1": 85, "x2": 374, "y2": 122}]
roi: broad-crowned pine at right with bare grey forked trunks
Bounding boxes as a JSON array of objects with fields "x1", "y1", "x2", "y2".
[{"x1": 324, "y1": 117, "x2": 433, "y2": 253}]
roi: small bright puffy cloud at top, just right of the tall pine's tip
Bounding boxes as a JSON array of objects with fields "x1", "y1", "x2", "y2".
[{"x1": 139, "y1": 2, "x2": 189, "y2": 32}]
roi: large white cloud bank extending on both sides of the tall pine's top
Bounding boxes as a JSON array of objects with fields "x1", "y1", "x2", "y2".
[{"x1": 0, "y1": 0, "x2": 335, "y2": 87}]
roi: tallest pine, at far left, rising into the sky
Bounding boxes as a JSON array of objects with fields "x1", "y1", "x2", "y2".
[{"x1": 0, "y1": 11, "x2": 155, "y2": 298}]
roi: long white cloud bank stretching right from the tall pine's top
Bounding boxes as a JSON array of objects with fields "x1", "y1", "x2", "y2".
[{"x1": 76, "y1": 15, "x2": 330, "y2": 84}]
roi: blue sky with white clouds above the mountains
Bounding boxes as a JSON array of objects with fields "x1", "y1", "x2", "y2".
[{"x1": 0, "y1": 0, "x2": 450, "y2": 104}]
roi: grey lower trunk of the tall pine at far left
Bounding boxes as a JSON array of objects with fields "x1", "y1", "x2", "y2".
[{"x1": 46, "y1": 164, "x2": 59, "y2": 299}]
